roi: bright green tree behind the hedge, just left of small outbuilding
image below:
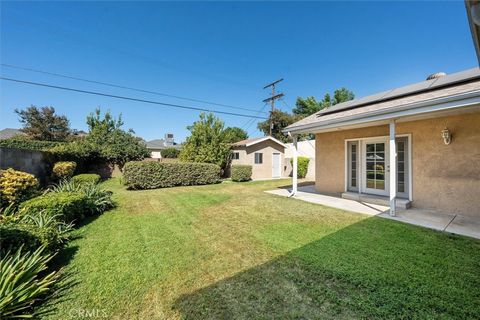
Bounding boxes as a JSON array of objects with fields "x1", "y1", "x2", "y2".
[{"x1": 180, "y1": 113, "x2": 230, "y2": 169}]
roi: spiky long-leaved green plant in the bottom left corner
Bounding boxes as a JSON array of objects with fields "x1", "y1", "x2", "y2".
[{"x1": 0, "y1": 247, "x2": 59, "y2": 319}]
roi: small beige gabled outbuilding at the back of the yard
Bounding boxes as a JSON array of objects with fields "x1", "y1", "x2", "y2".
[{"x1": 232, "y1": 136, "x2": 285, "y2": 180}]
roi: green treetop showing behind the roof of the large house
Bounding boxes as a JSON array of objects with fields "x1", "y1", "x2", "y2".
[{"x1": 292, "y1": 88, "x2": 355, "y2": 118}]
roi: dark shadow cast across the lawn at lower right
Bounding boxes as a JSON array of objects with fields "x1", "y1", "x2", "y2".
[{"x1": 174, "y1": 218, "x2": 480, "y2": 319}]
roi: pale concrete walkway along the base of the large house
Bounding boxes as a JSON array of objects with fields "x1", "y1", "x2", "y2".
[{"x1": 265, "y1": 185, "x2": 480, "y2": 239}]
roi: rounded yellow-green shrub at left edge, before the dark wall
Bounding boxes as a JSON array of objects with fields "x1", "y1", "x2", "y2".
[{"x1": 0, "y1": 168, "x2": 38, "y2": 206}]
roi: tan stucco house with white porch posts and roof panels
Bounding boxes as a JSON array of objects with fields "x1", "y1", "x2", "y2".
[{"x1": 285, "y1": 68, "x2": 480, "y2": 217}]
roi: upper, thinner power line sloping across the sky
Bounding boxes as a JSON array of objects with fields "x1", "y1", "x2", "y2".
[{"x1": 0, "y1": 63, "x2": 266, "y2": 112}]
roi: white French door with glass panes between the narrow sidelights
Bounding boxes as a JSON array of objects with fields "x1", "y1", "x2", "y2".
[{"x1": 361, "y1": 138, "x2": 390, "y2": 196}]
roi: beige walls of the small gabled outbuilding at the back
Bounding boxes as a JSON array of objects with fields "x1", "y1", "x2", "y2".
[{"x1": 232, "y1": 140, "x2": 285, "y2": 179}]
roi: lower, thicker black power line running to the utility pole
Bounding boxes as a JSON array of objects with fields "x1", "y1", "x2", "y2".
[{"x1": 0, "y1": 77, "x2": 267, "y2": 119}]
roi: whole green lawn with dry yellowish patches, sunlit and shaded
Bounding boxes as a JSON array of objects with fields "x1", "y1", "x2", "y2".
[{"x1": 44, "y1": 180, "x2": 480, "y2": 320}]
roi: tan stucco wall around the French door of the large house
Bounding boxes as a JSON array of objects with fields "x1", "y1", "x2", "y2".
[{"x1": 315, "y1": 113, "x2": 480, "y2": 217}]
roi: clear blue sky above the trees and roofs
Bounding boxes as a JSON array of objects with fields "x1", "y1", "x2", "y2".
[{"x1": 0, "y1": 1, "x2": 477, "y2": 141}]
